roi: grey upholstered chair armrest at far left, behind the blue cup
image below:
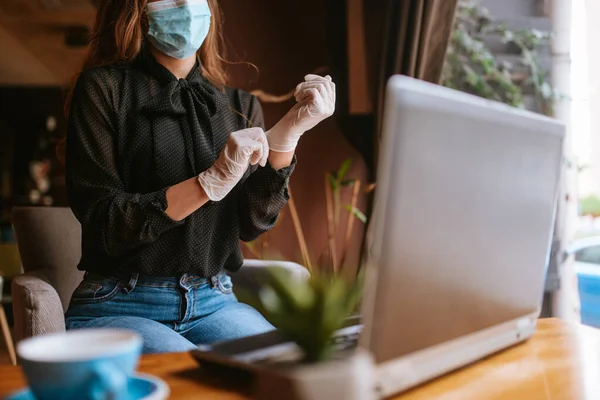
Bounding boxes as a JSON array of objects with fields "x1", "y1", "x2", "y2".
[{"x1": 12, "y1": 270, "x2": 65, "y2": 341}]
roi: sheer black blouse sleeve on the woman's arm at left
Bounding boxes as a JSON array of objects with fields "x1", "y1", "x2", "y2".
[{"x1": 66, "y1": 70, "x2": 182, "y2": 256}]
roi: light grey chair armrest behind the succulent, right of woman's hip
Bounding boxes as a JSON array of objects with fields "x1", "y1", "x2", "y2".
[{"x1": 231, "y1": 260, "x2": 310, "y2": 293}]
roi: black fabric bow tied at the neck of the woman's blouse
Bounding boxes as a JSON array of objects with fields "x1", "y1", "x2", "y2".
[{"x1": 143, "y1": 77, "x2": 229, "y2": 176}]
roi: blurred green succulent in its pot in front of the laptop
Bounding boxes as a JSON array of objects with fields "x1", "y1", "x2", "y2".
[{"x1": 241, "y1": 268, "x2": 375, "y2": 400}]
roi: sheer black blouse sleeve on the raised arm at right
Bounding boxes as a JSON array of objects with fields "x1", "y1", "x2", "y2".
[{"x1": 239, "y1": 97, "x2": 296, "y2": 241}]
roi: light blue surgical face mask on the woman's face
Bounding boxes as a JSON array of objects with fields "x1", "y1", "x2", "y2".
[{"x1": 146, "y1": 0, "x2": 211, "y2": 60}]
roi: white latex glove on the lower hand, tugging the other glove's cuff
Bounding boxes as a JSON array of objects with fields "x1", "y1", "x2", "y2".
[{"x1": 198, "y1": 128, "x2": 269, "y2": 201}]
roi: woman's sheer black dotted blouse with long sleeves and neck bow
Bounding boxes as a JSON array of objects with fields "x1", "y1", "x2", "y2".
[{"x1": 66, "y1": 47, "x2": 295, "y2": 277}]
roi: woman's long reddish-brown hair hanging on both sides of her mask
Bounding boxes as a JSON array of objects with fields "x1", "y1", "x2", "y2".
[{"x1": 56, "y1": 0, "x2": 228, "y2": 161}]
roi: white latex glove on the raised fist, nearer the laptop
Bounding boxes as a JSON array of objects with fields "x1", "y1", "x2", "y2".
[{"x1": 267, "y1": 75, "x2": 335, "y2": 152}]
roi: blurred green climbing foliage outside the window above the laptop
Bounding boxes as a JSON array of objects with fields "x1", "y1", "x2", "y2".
[{"x1": 442, "y1": 0, "x2": 562, "y2": 115}]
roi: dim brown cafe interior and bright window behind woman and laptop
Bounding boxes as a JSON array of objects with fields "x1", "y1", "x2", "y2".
[{"x1": 0, "y1": 0, "x2": 600, "y2": 363}]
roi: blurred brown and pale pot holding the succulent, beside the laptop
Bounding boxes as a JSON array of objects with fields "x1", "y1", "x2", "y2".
[{"x1": 255, "y1": 349, "x2": 377, "y2": 400}]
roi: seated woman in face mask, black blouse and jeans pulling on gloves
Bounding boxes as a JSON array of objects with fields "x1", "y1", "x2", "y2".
[{"x1": 66, "y1": 0, "x2": 335, "y2": 353}]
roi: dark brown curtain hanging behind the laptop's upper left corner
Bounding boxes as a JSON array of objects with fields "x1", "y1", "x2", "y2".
[{"x1": 329, "y1": 0, "x2": 457, "y2": 177}]
